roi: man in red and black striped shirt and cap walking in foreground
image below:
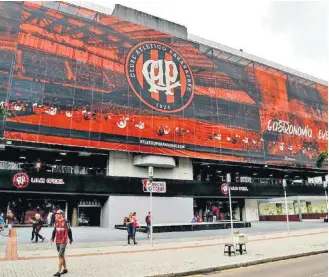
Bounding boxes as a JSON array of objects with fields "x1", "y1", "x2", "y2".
[{"x1": 50, "y1": 210, "x2": 73, "y2": 276}]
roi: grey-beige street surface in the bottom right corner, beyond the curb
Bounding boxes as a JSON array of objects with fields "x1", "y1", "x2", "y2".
[{"x1": 190, "y1": 254, "x2": 328, "y2": 277}]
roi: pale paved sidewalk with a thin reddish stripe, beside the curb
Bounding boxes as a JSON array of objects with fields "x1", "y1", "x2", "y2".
[{"x1": 0, "y1": 225, "x2": 328, "y2": 277}]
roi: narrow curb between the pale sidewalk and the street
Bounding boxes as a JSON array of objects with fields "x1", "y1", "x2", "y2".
[{"x1": 149, "y1": 249, "x2": 328, "y2": 277}]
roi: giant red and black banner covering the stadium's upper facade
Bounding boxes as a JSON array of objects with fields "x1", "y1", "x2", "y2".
[{"x1": 0, "y1": 2, "x2": 328, "y2": 166}]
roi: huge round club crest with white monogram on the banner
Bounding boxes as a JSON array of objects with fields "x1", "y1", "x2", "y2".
[{"x1": 126, "y1": 41, "x2": 194, "y2": 113}]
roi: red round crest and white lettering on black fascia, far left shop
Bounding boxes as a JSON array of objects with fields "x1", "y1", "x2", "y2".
[{"x1": 12, "y1": 172, "x2": 65, "y2": 189}]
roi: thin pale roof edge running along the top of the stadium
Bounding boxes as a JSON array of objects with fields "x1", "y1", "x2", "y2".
[{"x1": 63, "y1": 0, "x2": 328, "y2": 86}]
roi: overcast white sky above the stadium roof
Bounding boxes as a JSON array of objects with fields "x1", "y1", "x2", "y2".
[{"x1": 84, "y1": 0, "x2": 329, "y2": 80}]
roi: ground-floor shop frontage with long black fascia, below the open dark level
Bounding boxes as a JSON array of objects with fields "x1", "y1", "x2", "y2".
[{"x1": 0, "y1": 170, "x2": 324, "y2": 227}]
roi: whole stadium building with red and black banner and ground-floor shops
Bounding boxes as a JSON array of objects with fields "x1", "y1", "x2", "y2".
[{"x1": 0, "y1": 2, "x2": 328, "y2": 228}]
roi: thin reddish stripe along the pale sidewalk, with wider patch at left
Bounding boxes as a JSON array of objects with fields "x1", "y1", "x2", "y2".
[{"x1": 0, "y1": 229, "x2": 328, "y2": 262}]
